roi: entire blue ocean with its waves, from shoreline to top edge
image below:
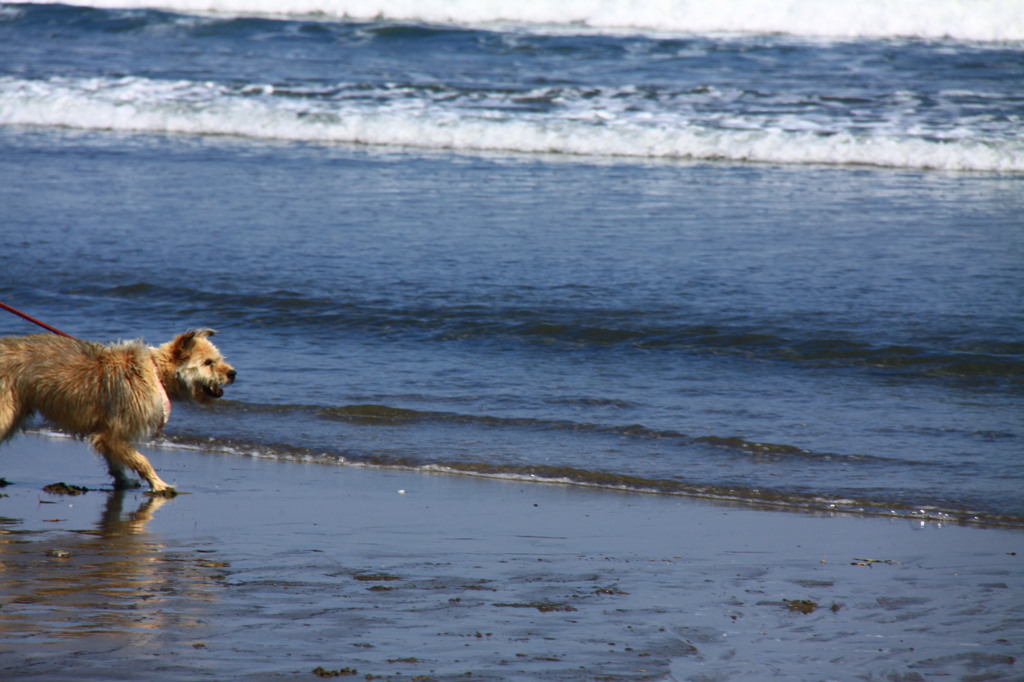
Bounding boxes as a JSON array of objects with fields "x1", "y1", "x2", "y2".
[{"x1": 0, "y1": 0, "x2": 1024, "y2": 527}]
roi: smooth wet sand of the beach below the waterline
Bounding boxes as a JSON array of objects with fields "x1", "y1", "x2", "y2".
[{"x1": 0, "y1": 434, "x2": 1024, "y2": 681}]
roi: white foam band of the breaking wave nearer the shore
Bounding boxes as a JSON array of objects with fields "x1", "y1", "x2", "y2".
[{"x1": 0, "y1": 77, "x2": 1024, "y2": 172}]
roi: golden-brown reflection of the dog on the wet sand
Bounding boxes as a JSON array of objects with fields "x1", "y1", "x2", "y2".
[{"x1": 0, "y1": 491, "x2": 226, "y2": 650}]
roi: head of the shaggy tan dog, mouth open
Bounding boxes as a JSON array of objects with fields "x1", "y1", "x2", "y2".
[{"x1": 158, "y1": 329, "x2": 237, "y2": 403}]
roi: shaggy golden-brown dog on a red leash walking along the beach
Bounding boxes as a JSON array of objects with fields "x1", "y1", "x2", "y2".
[{"x1": 0, "y1": 329, "x2": 236, "y2": 495}]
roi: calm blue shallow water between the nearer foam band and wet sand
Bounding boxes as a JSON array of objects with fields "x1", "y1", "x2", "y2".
[{"x1": 0, "y1": 129, "x2": 1024, "y2": 522}]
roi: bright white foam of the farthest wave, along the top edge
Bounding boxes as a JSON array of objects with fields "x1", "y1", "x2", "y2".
[{"x1": 24, "y1": 0, "x2": 1024, "y2": 41}]
